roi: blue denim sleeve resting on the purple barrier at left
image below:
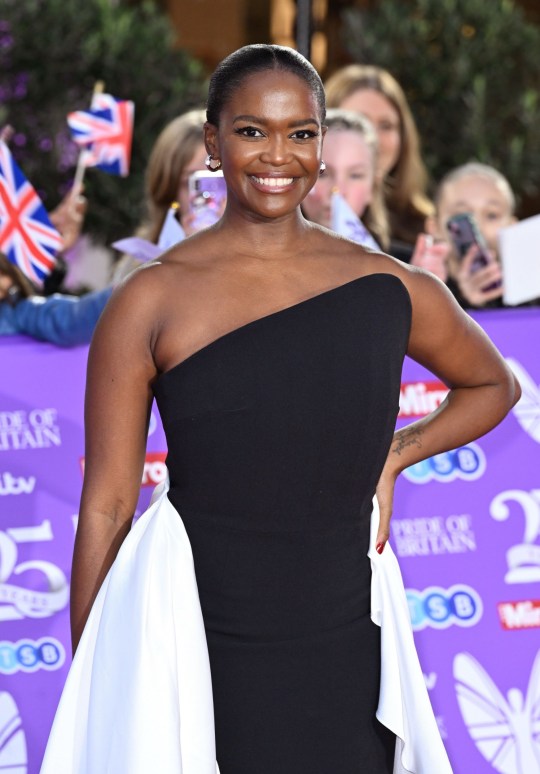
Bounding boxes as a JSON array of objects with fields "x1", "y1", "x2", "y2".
[{"x1": 0, "y1": 287, "x2": 113, "y2": 347}]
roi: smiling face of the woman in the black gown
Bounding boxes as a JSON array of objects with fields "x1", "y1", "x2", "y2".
[{"x1": 205, "y1": 69, "x2": 323, "y2": 220}]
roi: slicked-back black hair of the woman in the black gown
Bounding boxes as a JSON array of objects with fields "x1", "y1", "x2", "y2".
[{"x1": 206, "y1": 43, "x2": 326, "y2": 126}]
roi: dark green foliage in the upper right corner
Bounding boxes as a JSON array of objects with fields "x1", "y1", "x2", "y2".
[{"x1": 344, "y1": 0, "x2": 540, "y2": 209}]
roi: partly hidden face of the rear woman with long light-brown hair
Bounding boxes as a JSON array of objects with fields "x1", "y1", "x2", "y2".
[{"x1": 340, "y1": 89, "x2": 401, "y2": 178}]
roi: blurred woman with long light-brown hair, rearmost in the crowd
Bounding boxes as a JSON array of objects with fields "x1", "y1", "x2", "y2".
[{"x1": 325, "y1": 64, "x2": 433, "y2": 260}]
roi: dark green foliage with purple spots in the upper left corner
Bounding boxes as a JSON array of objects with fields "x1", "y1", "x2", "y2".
[{"x1": 0, "y1": 0, "x2": 204, "y2": 242}]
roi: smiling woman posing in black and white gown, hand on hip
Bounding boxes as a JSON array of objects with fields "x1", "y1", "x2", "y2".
[{"x1": 45, "y1": 45, "x2": 519, "y2": 774}]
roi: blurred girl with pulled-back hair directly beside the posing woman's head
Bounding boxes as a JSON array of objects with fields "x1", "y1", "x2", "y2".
[{"x1": 302, "y1": 109, "x2": 389, "y2": 250}]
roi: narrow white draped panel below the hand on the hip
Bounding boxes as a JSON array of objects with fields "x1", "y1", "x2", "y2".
[{"x1": 368, "y1": 498, "x2": 452, "y2": 774}]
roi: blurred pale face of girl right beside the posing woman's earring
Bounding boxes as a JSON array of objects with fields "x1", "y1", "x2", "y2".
[{"x1": 303, "y1": 129, "x2": 375, "y2": 228}]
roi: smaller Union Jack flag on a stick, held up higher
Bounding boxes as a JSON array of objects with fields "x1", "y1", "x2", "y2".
[{"x1": 67, "y1": 94, "x2": 135, "y2": 177}]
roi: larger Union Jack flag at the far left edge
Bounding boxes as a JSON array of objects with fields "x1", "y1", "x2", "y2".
[{"x1": 0, "y1": 141, "x2": 62, "y2": 285}]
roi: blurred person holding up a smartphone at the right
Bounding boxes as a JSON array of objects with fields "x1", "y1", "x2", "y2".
[{"x1": 426, "y1": 162, "x2": 516, "y2": 308}]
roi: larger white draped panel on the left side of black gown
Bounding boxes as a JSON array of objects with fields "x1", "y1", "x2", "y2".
[{"x1": 41, "y1": 483, "x2": 218, "y2": 774}]
